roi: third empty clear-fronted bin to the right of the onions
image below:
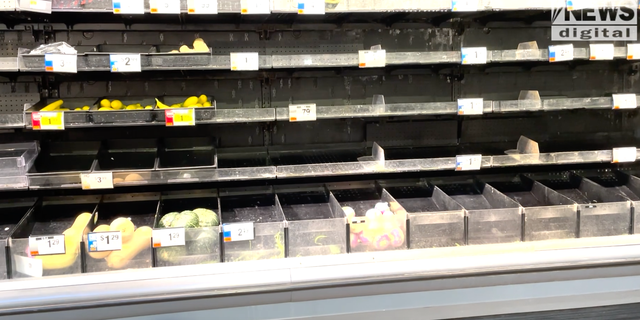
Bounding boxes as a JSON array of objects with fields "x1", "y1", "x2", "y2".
[{"x1": 486, "y1": 175, "x2": 578, "y2": 241}]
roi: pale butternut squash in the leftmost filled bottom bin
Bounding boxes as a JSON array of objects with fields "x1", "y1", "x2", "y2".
[{"x1": 27, "y1": 212, "x2": 91, "y2": 270}]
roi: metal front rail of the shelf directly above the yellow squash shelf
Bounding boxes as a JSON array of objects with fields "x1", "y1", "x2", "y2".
[{"x1": 16, "y1": 47, "x2": 627, "y2": 72}]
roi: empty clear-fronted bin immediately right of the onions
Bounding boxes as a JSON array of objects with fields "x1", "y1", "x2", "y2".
[{"x1": 380, "y1": 180, "x2": 466, "y2": 249}]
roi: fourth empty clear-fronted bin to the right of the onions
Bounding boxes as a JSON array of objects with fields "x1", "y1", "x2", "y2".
[{"x1": 532, "y1": 172, "x2": 631, "y2": 238}]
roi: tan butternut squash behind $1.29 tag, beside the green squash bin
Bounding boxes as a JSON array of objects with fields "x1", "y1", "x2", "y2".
[{"x1": 89, "y1": 218, "x2": 152, "y2": 269}]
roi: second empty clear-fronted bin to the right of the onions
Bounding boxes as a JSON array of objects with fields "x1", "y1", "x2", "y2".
[{"x1": 435, "y1": 180, "x2": 522, "y2": 244}]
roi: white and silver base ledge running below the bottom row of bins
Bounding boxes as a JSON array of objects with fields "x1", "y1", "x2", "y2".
[{"x1": 0, "y1": 236, "x2": 640, "y2": 319}]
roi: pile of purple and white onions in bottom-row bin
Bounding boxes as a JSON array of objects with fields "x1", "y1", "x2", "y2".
[{"x1": 342, "y1": 202, "x2": 406, "y2": 250}]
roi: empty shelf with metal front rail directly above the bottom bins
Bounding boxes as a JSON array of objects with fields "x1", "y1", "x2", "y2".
[{"x1": 16, "y1": 142, "x2": 640, "y2": 189}]
